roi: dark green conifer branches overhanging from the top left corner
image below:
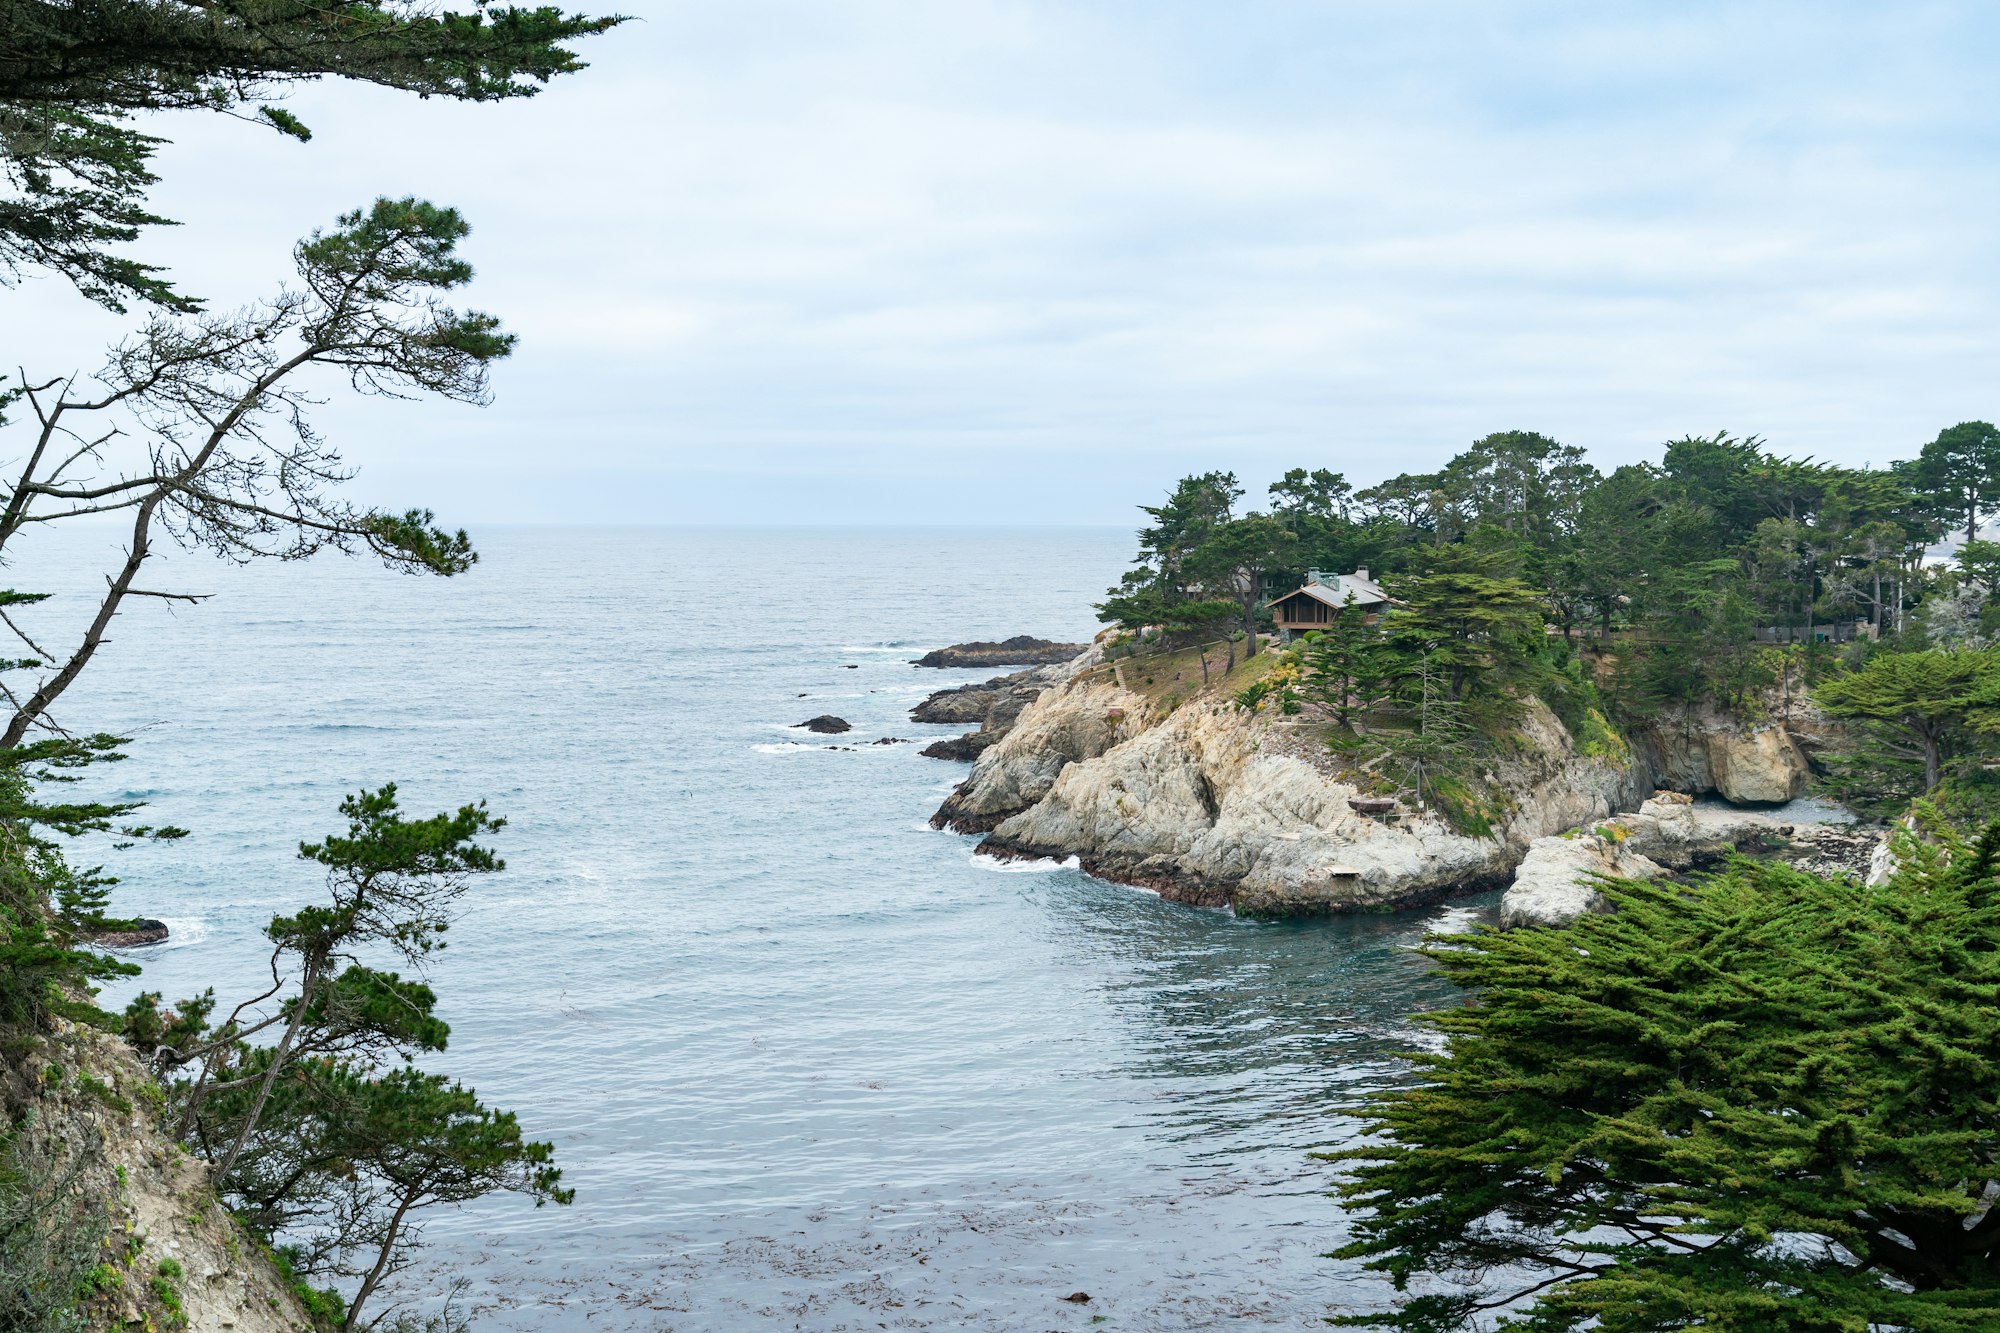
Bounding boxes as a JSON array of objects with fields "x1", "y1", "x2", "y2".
[{"x1": 0, "y1": 0, "x2": 622, "y2": 310}]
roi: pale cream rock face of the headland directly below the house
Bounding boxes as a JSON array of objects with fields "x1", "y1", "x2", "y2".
[{"x1": 964, "y1": 681, "x2": 1638, "y2": 915}]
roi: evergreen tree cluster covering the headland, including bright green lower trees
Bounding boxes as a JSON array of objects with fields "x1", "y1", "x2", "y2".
[{"x1": 1100, "y1": 422, "x2": 2000, "y2": 813}]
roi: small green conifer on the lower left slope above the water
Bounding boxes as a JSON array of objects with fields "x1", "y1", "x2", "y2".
[{"x1": 135, "y1": 787, "x2": 570, "y2": 1327}]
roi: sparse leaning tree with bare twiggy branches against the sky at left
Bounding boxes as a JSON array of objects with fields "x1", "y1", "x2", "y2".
[{"x1": 0, "y1": 200, "x2": 514, "y2": 749}]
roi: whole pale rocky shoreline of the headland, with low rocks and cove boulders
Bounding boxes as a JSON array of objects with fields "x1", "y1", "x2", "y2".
[{"x1": 912, "y1": 646, "x2": 1874, "y2": 925}]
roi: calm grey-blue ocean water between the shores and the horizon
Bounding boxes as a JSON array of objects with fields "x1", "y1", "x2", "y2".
[{"x1": 43, "y1": 528, "x2": 1470, "y2": 1331}]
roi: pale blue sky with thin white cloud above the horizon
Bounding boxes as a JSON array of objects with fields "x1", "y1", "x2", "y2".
[{"x1": 0, "y1": 0, "x2": 2000, "y2": 524}]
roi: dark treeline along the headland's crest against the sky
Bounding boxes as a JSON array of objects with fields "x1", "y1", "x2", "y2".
[{"x1": 1102, "y1": 422, "x2": 2000, "y2": 709}]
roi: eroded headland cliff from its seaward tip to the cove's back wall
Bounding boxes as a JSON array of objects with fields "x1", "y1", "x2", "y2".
[{"x1": 932, "y1": 648, "x2": 1810, "y2": 917}]
